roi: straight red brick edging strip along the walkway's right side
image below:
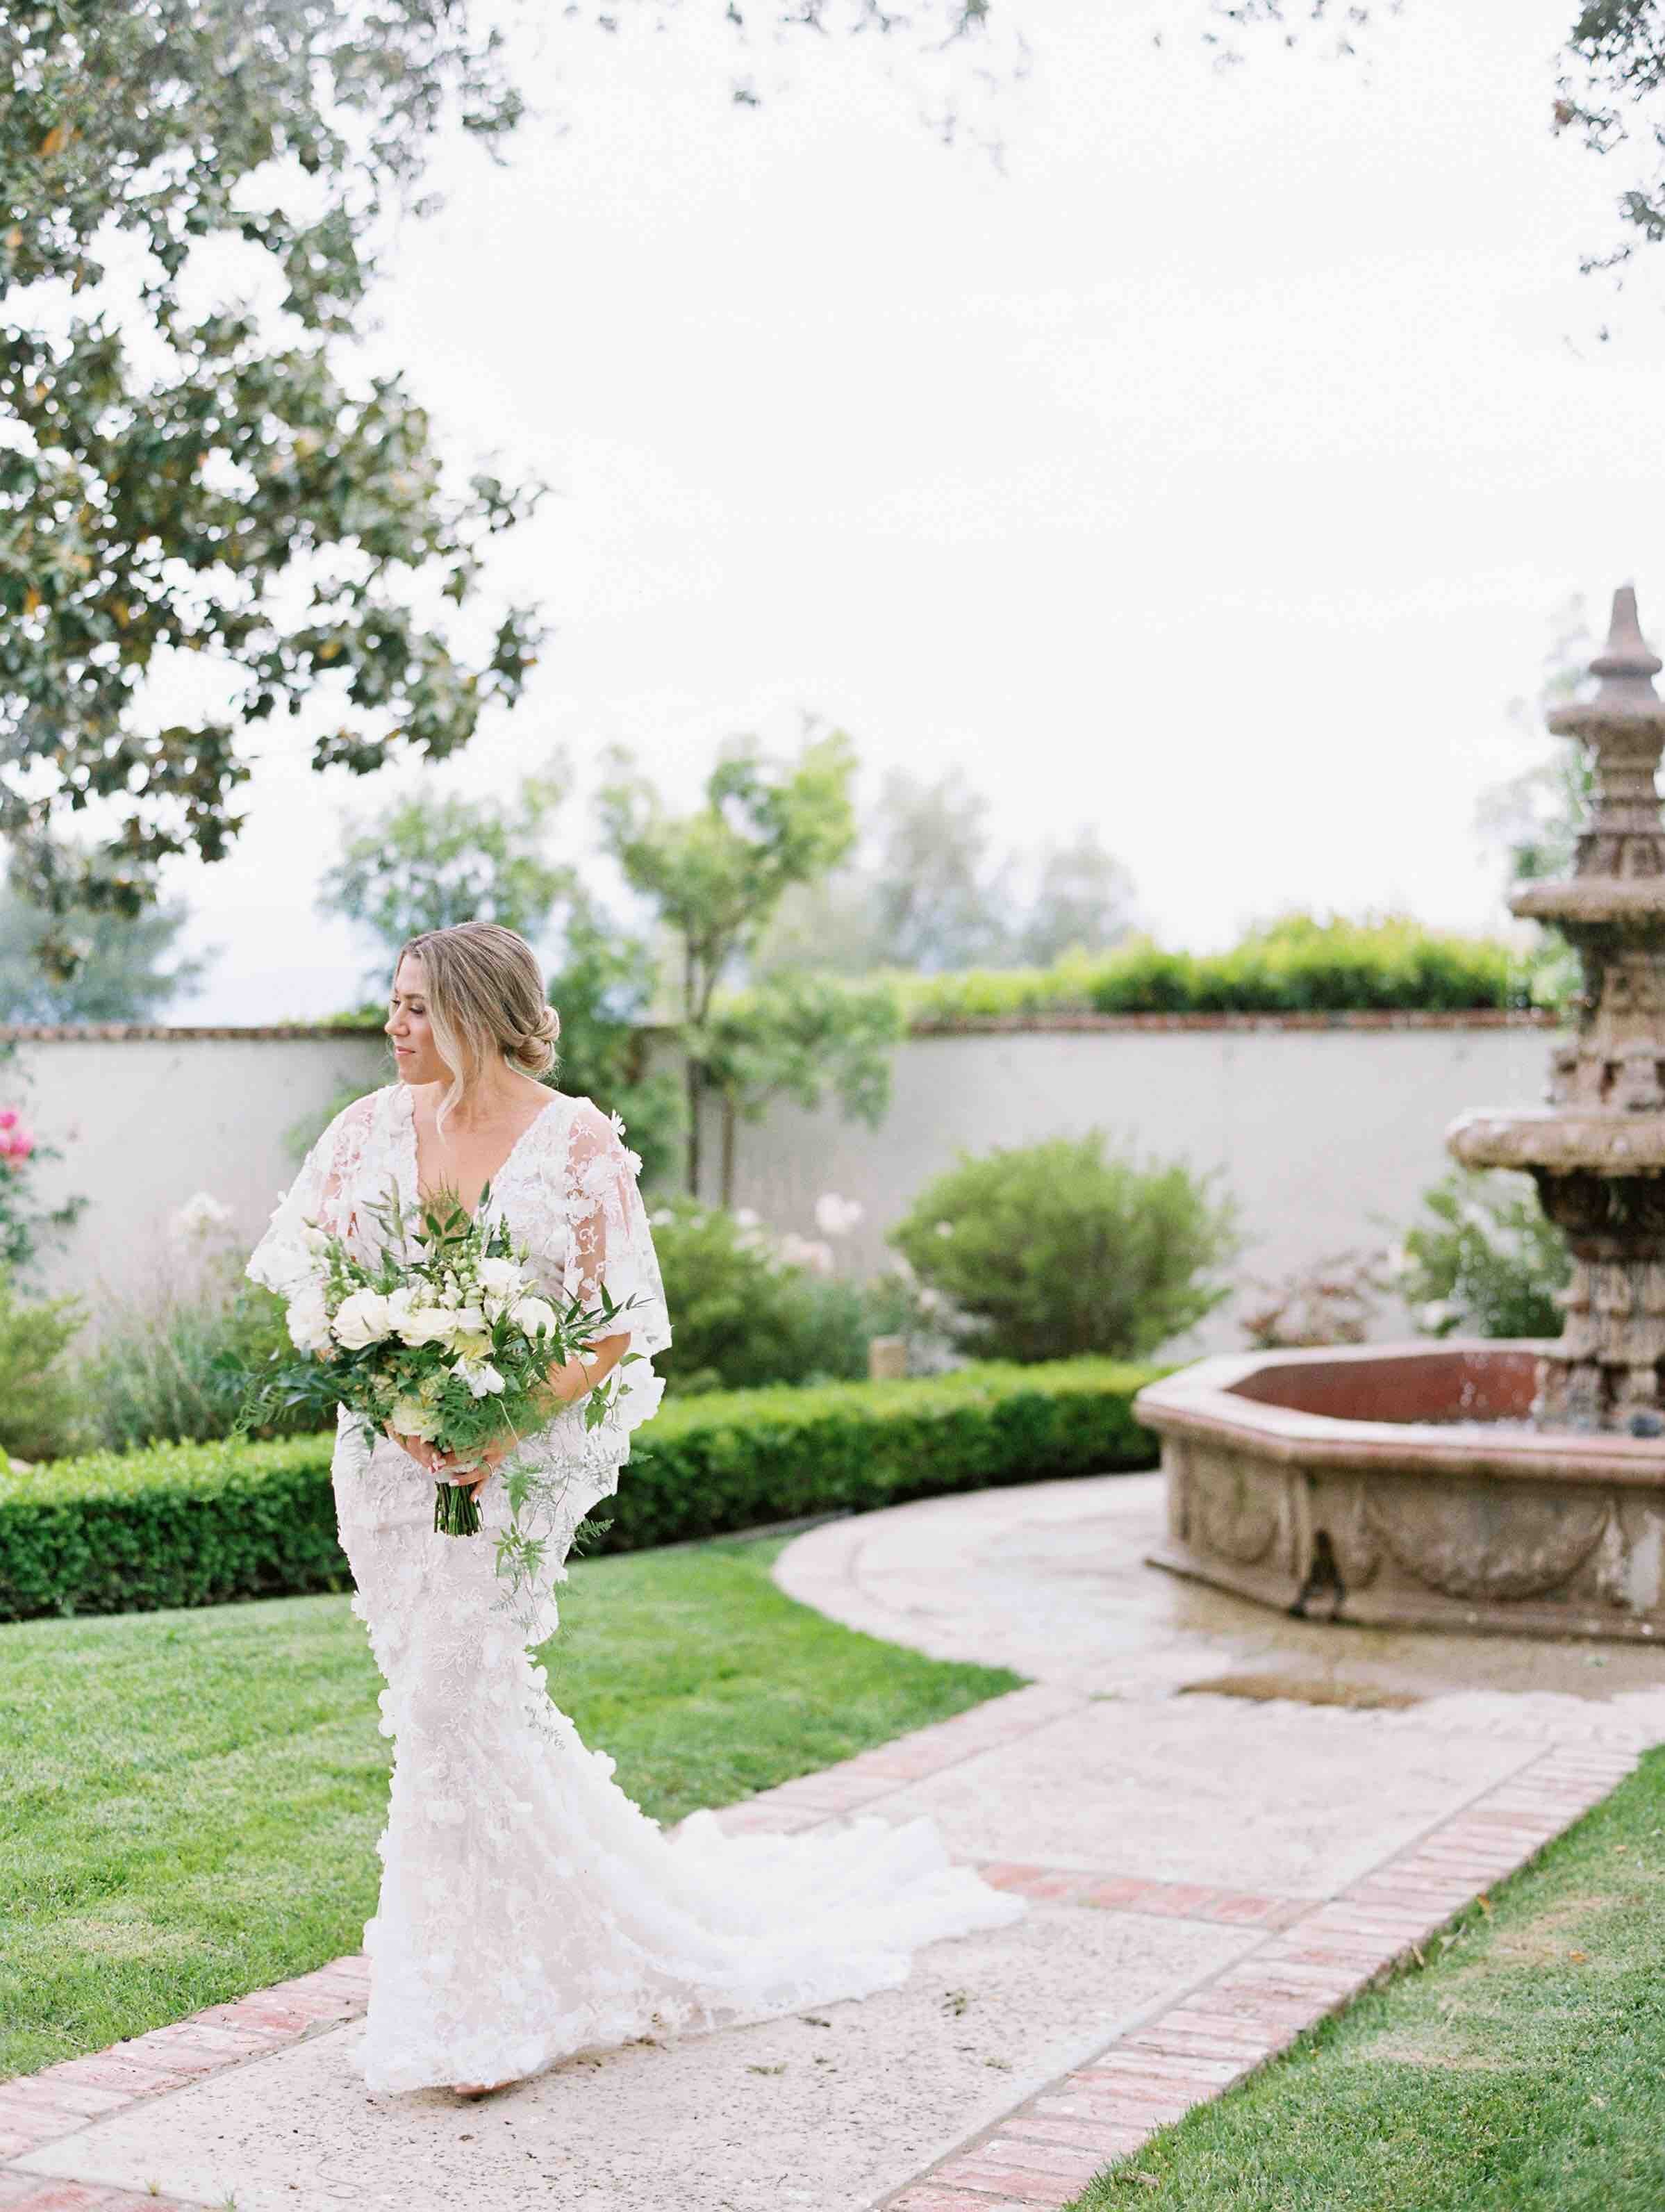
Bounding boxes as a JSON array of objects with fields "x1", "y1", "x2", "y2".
[{"x1": 884, "y1": 1745, "x2": 1637, "y2": 2212}]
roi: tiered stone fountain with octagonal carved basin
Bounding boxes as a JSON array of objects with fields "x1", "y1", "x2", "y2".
[{"x1": 1138, "y1": 588, "x2": 1665, "y2": 1639}]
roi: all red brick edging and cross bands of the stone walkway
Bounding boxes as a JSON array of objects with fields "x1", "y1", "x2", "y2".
[{"x1": 0, "y1": 1683, "x2": 1637, "y2": 2212}]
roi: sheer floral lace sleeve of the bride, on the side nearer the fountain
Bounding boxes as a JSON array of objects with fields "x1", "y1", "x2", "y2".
[{"x1": 562, "y1": 1099, "x2": 670, "y2": 1431}]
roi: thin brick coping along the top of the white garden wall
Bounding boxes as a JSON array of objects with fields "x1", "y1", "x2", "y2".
[{"x1": 0, "y1": 1007, "x2": 1561, "y2": 1044}]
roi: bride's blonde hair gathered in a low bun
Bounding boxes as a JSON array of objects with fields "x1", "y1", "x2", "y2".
[{"x1": 394, "y1": 923, "x2": 562, "y2": 1128}]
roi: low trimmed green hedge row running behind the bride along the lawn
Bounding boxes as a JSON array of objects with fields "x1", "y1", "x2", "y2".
[{"x1": 0, "y1": 1360, "x2": 1161, "y2": 1621}]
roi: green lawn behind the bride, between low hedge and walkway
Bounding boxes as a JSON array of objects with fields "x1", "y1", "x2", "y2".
[{"x1": 0, "y1": 1540, "x2": 1019, "y2": 2077}]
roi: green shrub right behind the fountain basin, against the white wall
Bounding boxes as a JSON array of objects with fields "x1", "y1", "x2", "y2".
[{"x1": 1393, "y1": 1168, "x2": 1572, "y2": 1336}]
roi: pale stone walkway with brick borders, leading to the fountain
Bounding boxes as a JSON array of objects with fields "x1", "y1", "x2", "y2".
[{"x1": 0, "y1": 1478, "x2": 1665, "y2": 2212}]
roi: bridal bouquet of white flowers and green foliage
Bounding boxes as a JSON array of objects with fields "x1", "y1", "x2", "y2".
[{"x1": 245, "y1": 1190, "x2": 637, "y2": 1535}]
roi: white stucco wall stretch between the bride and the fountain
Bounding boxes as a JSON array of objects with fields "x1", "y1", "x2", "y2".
[{"x1": 705, "y1": 1026, "x2": 1550, "y2": 1349}]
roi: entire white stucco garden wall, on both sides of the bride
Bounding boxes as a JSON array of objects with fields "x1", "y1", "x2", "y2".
[{"x1": 0, "y1": 1024, "x2": 1550, "y2": 1349}]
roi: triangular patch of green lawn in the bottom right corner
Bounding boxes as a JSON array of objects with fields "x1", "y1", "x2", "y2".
[{"x1": 1079, "y1": 1752, "x2": 1665, "y2": 2212}]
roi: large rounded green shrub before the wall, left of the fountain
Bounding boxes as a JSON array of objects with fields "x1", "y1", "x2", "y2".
[{"x1": 889, "y1": 1130, "x2": 1239, "y2": 1360}]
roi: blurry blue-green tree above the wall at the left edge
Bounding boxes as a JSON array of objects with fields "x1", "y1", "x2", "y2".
[{"x1": 0, "y1": 845, "x2": 213, "y2": 1022}]
